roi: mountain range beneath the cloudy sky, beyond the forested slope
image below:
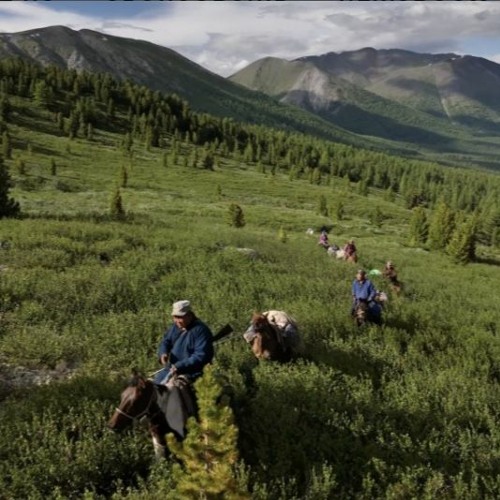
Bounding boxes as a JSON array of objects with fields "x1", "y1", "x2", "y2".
[{"x1": 0, "y1": 26, "x2": 500, "y2": 168}]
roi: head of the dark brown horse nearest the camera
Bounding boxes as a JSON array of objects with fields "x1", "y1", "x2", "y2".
[{"x1": 108, "y1": 373, "x2": 156, "y2": 431}]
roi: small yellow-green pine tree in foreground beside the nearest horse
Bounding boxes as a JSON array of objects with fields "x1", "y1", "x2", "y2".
[{"x1": 167, "y1": 365, "x2": 251, "y2": 500}]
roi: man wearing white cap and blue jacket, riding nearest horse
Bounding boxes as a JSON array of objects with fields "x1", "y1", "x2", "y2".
[{"x1": 154, "y1": 300, "x2": 214, "y2": 384}]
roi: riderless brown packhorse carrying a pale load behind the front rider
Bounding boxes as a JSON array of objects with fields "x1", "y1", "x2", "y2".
[{"x1": 244, "y1": 311, "x2": 299, "y2": 363}]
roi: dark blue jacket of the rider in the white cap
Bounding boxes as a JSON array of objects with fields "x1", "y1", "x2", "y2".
[{"x1": 158, "y1": 318, "x2": 214, "y2": 380}]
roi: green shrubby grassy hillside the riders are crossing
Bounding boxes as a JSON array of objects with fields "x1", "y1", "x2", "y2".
[{"x1": 0, "y1": 92, "x2": 500, "y2": 499}]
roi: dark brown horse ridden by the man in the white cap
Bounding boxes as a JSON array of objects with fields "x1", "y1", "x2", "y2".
[{"x1": 108, "y1": 372, "x2": 195, "y2": 460}]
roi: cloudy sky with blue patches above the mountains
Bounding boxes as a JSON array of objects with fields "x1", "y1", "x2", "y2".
[{"x1": 0, "y1": 0, "x2": 500, "y2": 76}]
